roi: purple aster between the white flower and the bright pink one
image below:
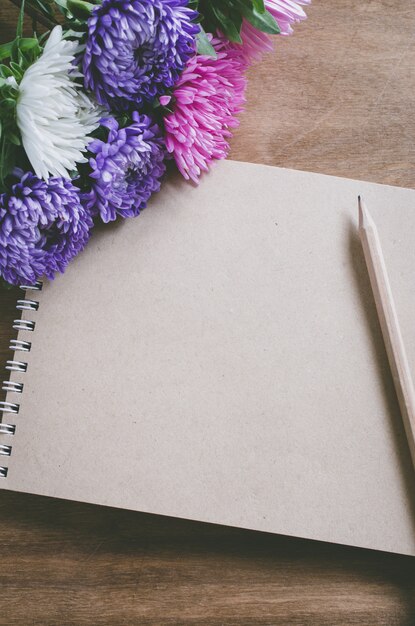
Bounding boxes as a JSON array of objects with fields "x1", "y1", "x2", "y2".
[{"x1": 84, "y1": 112, "x2": 166, "y2": 222}]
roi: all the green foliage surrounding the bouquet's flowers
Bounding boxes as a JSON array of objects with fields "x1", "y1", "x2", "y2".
[{"x1": 0, "y1": 0, "x2": 280, "y2": 192}]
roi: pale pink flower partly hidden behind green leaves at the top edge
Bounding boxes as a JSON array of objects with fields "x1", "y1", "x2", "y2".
[{"x1": 236, "y1": 0, "x2": 311, "y2": 63}]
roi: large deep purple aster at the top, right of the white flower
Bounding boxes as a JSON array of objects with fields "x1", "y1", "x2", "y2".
[{"x1": 82, "y1": 0, "x2": 200, "y2": 110}]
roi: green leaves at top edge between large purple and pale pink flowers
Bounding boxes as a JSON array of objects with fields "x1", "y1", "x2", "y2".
[{"x1": 198, "y1": 0, "x2": 281, "y2": 43}]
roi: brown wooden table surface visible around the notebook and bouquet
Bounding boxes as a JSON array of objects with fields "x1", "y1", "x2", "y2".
[{"x1": 0, "y1": 0, "x2": 415, "y2": 626}]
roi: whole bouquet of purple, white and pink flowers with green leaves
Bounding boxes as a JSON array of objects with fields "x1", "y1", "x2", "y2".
[{"x1": 0, "y1": 0, "x2": 310, "y2": 285}]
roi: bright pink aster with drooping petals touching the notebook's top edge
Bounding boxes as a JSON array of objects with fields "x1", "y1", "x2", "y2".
[{"x1": 162, "y1": 38, "x2": 246, "y2": 183}]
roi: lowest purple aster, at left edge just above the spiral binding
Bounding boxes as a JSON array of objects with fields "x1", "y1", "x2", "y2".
[{"x1": 0, "y1": 170, "x2": 93, "y2": 285}]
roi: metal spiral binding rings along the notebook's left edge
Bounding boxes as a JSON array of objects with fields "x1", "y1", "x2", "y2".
[{"x1": 0, "y1": 281, "x2": 42, "y2": 478}]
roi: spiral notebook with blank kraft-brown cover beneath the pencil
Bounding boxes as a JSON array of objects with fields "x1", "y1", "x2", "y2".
[{"x1": 0, "y1": 161, "x2": 415, "y2": 555}]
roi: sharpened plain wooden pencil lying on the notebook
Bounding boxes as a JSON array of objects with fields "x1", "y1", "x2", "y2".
[{"x1": 359, "y1": 196, "x2": 415, "y2": 468}]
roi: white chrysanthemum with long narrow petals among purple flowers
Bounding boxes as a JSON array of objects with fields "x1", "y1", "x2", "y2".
[{"x1": 16, "y1": 26, "x2": 102, "y2": 180}]
